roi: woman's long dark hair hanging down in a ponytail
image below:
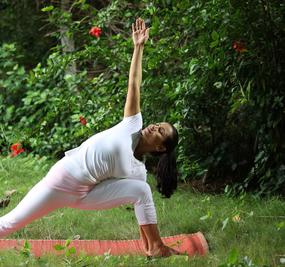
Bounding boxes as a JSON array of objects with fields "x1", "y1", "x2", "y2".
[{"x1": 152, "y1": 124, "x2": 178, "y2": 198}]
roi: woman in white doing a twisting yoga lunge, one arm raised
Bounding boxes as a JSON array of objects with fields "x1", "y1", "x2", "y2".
[{"x1": 0, "y1": 18, "x2": 178, "y2": 256}]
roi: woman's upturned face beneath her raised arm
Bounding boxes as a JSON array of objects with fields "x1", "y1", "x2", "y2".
[{"x1": 142, "y1": 122, "x2": 173, "y2": 152}]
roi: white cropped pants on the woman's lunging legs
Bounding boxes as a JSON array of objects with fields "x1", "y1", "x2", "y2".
[{"x1": 0, "y1": 161, "x2": 157, "y2": 238}]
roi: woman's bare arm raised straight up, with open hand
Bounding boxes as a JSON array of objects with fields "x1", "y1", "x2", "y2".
[{"x1": 124, "y1": 18, "x2": 149, "y2": 117}]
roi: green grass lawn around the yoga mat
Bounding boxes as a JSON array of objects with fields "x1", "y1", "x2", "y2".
[{"x1": 0, "y1": 157, "x2": 285, "y2": 266}]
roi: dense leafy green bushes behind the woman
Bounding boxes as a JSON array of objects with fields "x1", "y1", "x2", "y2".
[{"x1": 0, "y1": 0, "x2": 285, "y2": 195}]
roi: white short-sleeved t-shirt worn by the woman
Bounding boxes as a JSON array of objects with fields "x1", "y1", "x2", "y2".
[{"x1": 61, "y1": 113, "x2": 146, "y2": 184}]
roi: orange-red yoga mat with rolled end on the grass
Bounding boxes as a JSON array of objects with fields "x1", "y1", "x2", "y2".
[{"x1": 0, "y1": 232, "x2": 208, "y2": 257}]
